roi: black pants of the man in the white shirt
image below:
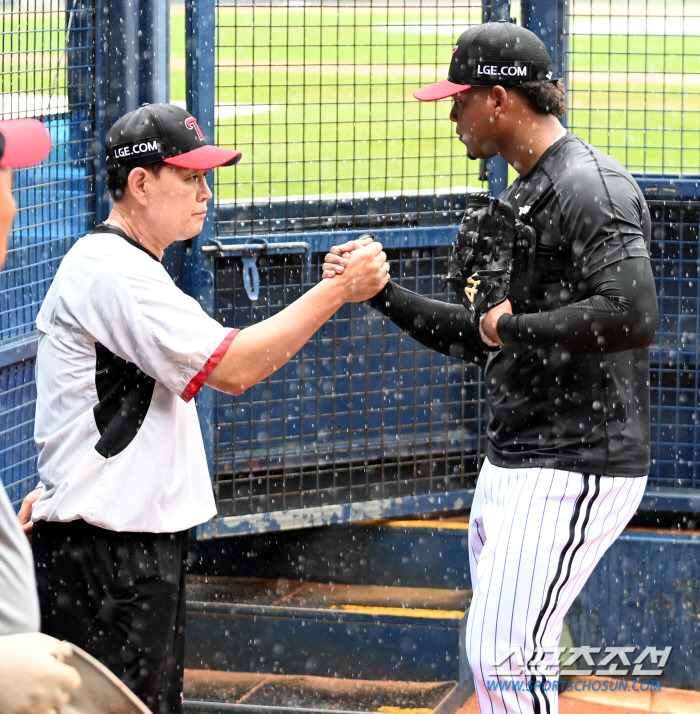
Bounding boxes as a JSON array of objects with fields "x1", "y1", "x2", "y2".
[{"x1": 32, "y1": 520, "x2": 188, "y2": 714}]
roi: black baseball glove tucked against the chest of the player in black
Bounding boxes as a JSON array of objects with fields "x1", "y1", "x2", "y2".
[{"x1": 447, "y1": 194, "x2": 535, "y2": 342}]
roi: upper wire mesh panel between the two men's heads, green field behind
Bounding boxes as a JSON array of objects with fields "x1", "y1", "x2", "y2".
[{"x1": 216, "y1": 0, "x2": 483, "y2": 234}]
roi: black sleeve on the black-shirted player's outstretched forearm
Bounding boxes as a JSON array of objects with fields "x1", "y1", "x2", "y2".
[{"x1": 367, "y1": 281, "x2": 488, "y2": 365}]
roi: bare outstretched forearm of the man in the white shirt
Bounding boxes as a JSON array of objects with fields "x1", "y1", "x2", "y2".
[{"x1": 207, "y1": 280, "x2": 344, "y2": 394}]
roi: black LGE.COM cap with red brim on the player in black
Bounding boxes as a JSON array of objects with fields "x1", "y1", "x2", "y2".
[{"x1": 413, "y1": 20, "x2": 556, "y2": 102}]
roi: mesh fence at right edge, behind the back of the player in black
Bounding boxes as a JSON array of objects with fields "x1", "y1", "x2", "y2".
[{"x1": 567, "y1": 0, "x2": 700, "y2": 488}]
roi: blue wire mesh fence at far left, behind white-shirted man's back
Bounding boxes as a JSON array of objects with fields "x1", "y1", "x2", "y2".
[{"x1": 0, "y1": 0, "x2": 95, "y2": 505}]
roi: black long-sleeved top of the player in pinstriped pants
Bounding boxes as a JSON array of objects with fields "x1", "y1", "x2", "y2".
[{"x1": 370, "y1": 134, "x2": 658, "y2": 477}]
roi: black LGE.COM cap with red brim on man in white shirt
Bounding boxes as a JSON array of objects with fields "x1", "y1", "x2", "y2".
[{"x1": 105, "y1": 104, "x2": 242, "y2": 174}]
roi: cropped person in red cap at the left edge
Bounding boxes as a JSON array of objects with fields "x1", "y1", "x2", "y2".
[{"x1": 0, "y1": 119, "x2": 80, "y2": 714}]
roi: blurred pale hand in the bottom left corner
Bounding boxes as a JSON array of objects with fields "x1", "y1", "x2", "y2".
[{"x1": 0, "y1": 632, "x2": 81, "y2": 714}]
